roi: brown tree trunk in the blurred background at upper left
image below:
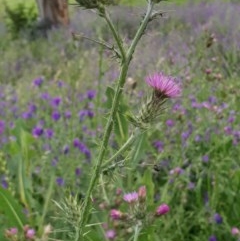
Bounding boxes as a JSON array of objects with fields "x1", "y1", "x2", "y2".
[{"x1": 36, "y1": 0, "x2": 69, "y2": 28}]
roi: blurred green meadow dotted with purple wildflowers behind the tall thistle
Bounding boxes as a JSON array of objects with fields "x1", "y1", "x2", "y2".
[{"x1": 0, "y1": 0, "x2": 240, "y2": 241}]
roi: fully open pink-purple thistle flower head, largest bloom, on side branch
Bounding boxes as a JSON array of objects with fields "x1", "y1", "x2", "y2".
[{"x1": 146, "y1": 73, "x2": 181, "y2": 99}]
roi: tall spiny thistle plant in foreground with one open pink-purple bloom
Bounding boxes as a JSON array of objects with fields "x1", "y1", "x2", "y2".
[{"x1": 74, "y1": 0, "x2": 180, "y2": 241}]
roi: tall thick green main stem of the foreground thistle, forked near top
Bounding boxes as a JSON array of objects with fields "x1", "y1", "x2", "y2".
[{"x1": 78, "y1": 2, "x2": 153, "y2": 241}]
